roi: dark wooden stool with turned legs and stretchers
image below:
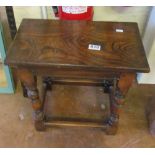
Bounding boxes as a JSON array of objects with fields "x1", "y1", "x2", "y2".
[{"x1": 5, "y1": 19, "x2": 149, "y2": 134}]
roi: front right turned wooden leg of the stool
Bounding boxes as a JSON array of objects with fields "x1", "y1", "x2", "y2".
[{"x1": 106, "y1": 73, "x2": 135, "y2": 134}]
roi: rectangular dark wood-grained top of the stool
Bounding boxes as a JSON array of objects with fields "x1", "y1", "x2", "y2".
[{"x1": 5, "y1": 19, "x2": 149, "y2": 72}]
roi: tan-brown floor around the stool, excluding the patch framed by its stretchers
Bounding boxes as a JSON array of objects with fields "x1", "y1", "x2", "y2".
[{"x1": 0, "y1": 84, "x2": 155, "y2": 148}]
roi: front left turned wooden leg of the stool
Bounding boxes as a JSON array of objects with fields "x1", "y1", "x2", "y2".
[{"x1": 17, "y1": 69, "x2": 45, "y2": 131}]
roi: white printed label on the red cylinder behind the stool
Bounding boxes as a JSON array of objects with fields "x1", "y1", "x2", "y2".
[{"x1": 62, "y1": 6, "x2": 87, "y2": 14}]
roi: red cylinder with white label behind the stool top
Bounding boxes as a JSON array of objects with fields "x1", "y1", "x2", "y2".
[{"x1": 58, "y1": 6, "x2": 93, "y2": 20}]
